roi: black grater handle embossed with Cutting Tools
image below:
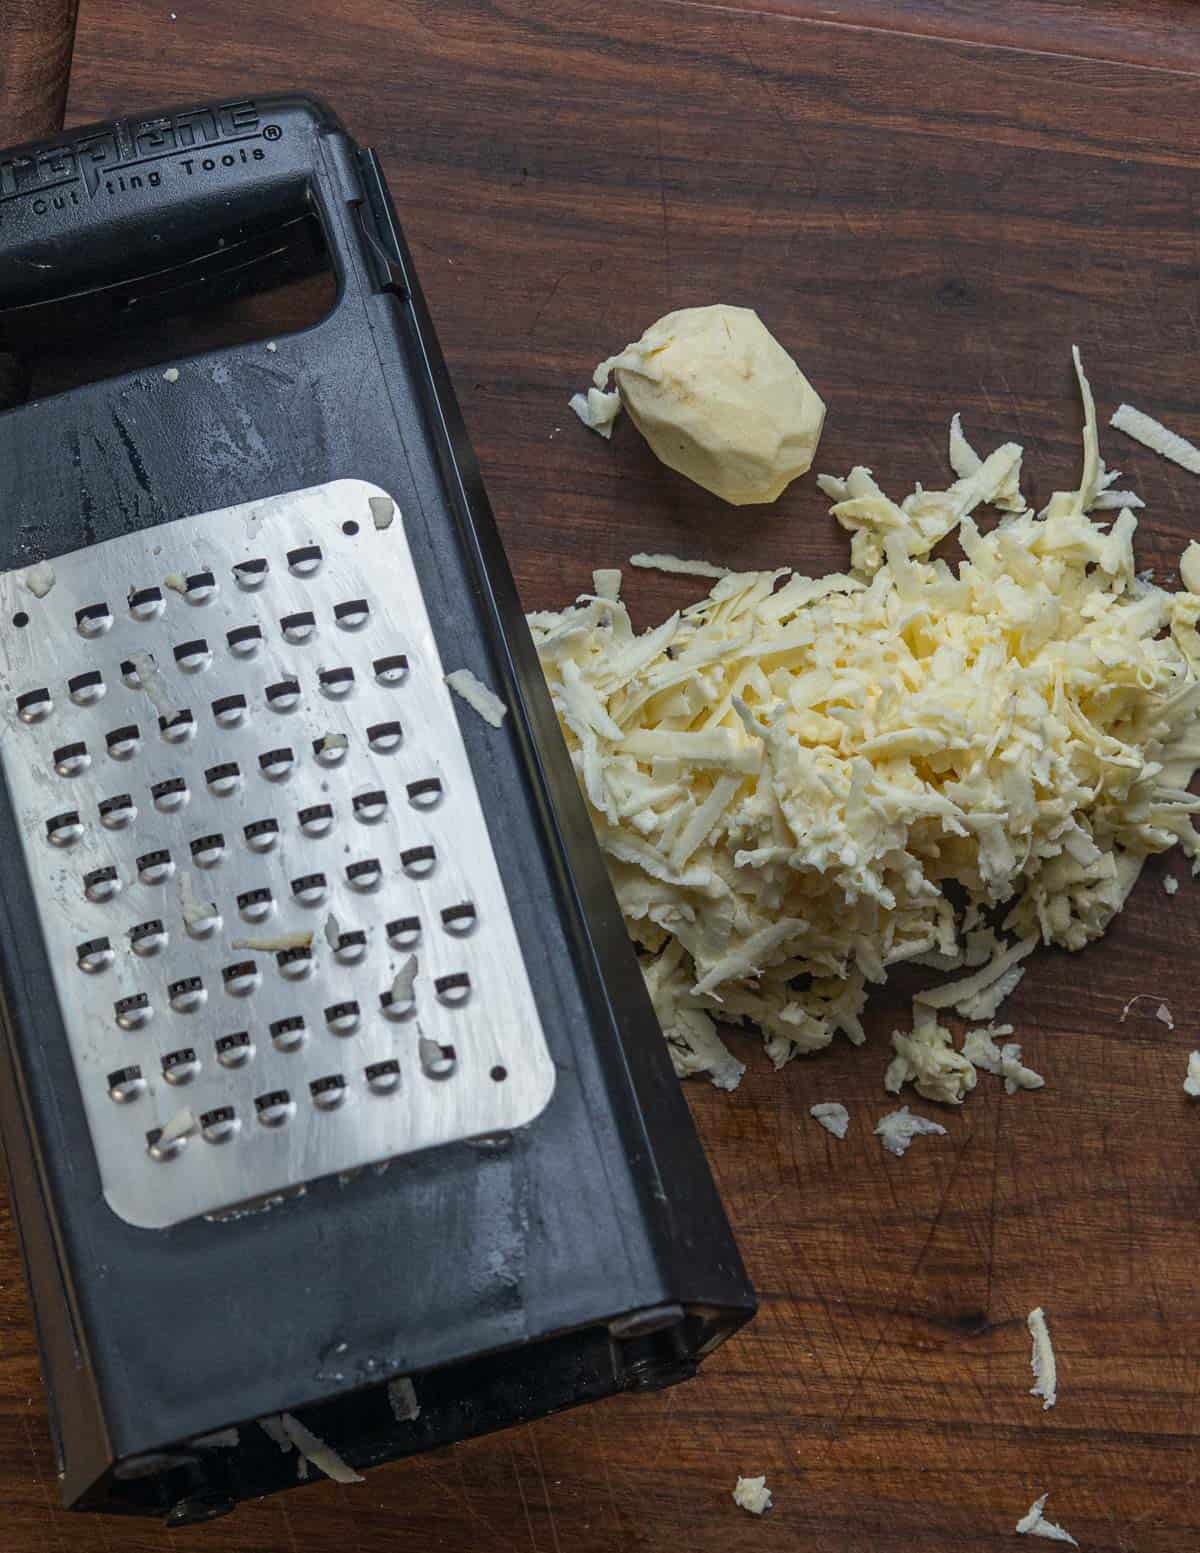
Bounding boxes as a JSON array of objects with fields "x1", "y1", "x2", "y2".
[{"x1": 0, "y1": 95, "x2": 369, "y2": 324}]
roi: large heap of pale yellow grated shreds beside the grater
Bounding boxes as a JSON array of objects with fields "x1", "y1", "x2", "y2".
[{"x1": 529, "y1": 351, "x2": 1200, "y2": 1103}]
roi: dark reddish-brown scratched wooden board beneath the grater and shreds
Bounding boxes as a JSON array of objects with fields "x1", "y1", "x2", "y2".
[{"x1": 0, "y1": 0, "x2": 1200, "y2": 1553}]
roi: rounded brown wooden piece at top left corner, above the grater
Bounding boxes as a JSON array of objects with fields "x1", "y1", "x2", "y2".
[{"x1": 0, "y1": 0, "x2": 79, "y2": 146}]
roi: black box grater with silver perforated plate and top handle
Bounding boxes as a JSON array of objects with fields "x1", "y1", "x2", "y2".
[{"x1": 0, "y1": 96, "x2": 753, "y2": 1523}]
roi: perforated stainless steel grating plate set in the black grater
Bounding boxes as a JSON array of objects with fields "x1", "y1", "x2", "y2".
[{"x1": 0, "y1": 480, "x2": 554, "y2": 1228}]
